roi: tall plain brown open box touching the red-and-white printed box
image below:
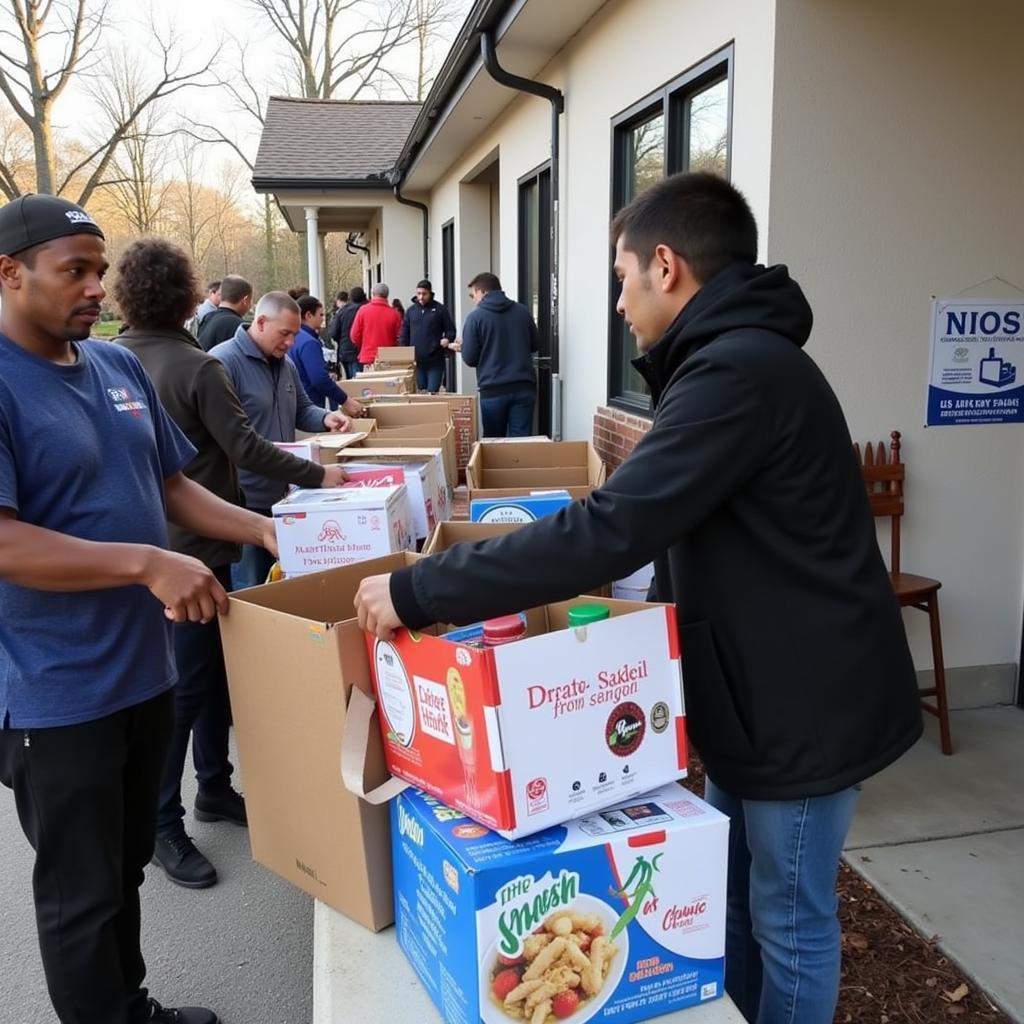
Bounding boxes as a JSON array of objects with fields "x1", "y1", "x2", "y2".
[{"x1": 220, "y1": 554, "x2": 417, "y2": 931}]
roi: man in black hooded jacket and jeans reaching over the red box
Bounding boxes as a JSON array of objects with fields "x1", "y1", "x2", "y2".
[{"x1": 355, "y1": 174, "x2": 923, "y2": 1024}]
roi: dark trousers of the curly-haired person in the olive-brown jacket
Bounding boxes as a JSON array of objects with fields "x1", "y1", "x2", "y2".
[{"x1": 157, "y1": 565, "x2": 232, "y2": 836}]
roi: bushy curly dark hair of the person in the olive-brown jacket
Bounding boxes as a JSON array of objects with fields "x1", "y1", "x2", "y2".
[{"x1": 114, "y1": 239, "x2": 199, "y2": 330}]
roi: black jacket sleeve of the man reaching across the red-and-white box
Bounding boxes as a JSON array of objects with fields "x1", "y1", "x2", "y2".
[{"x1": 391, "y1": 350, "x2": 770, "y2": 629}]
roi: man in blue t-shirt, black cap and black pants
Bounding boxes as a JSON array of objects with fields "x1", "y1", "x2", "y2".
[{"x1": 0, "y1": 196, "x2": 274, "y2": 1024}]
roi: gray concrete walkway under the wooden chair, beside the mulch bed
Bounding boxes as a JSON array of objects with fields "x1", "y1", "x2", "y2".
[{"x1": 846, "y1": 707, "x2": 1024, "y2": 1022}]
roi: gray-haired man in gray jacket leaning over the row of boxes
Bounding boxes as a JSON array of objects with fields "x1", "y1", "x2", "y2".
[{"x1": 210, "y1": 292, "x2": 351, "y2": 590}]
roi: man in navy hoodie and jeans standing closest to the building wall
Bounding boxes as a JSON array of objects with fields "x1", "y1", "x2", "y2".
[{"x1": 462, "y1": 272, "x2": 540, "y2": 437}]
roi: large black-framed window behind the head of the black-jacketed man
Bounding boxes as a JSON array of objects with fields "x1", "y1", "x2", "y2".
[{"x1": 608, "y1": 46, "x2": 732, "y2": 414}]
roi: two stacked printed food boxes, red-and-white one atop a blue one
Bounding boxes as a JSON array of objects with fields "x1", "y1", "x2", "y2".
[{"x1": 368, "y1": 598, "x2": 728, "y2": 1024}]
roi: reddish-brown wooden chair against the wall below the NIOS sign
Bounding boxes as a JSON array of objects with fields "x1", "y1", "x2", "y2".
[{"x1": 853, "y1": 430, "x2": 953, "y2": 754}]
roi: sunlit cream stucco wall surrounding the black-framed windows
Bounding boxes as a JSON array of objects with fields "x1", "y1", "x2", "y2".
[{"x1": 417, "y1": 0, "x2": 774, "y2": 438}]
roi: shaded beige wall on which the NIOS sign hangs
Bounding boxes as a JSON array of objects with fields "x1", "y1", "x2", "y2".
[{"x1": 768, "y1": 0, "x2": 1024, "y2": 693}]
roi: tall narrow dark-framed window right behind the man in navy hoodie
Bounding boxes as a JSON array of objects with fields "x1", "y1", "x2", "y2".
[{"x1": 518, "y1": 164, "x2": 551, "y2": 434}]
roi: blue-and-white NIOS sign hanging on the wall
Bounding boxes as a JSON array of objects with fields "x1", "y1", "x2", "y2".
[{"x1": 926, "y1": 298, "x2": 1024, "y2": 427}]
